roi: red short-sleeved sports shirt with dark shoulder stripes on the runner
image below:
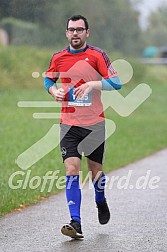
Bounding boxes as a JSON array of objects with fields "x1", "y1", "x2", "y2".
[{"x1": 46, "y1": 45, "x2": 118, "y2": 126}]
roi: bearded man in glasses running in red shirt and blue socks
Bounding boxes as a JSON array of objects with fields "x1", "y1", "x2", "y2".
[{"x1": 44, "y1": 15, "x2": 122, "y2": 238}]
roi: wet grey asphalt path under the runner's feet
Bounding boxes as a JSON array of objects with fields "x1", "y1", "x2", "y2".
[{"x1": 0, "y1": 149, "x2": 167, "y2": 252}]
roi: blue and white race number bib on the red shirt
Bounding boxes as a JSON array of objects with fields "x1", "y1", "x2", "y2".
[{"x1": 68, "y1": 87, "x2": 92, "y2": 106}]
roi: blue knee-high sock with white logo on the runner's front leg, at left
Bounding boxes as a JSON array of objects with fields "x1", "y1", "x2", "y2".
[{"x1": 66, "y1": 175, "x2": 81, "y2": 222}]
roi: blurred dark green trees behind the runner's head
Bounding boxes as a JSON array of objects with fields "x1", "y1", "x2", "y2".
[{"x1": 0, "y1": 0, "x2": 142, "y2": 54}]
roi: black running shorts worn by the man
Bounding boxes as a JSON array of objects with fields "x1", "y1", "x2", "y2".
[{"x1": 60, "y1": 121, "x2": 105, "y2": 164}]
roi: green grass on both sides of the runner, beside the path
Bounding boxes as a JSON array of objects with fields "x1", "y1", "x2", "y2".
[{"x1": 0, "y1": 48, "x2": 167, "y2": 215}]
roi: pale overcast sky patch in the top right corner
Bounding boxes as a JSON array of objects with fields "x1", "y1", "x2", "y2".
[{"x1": 136, "y1": 0, "x2": 167, "y2": 28}]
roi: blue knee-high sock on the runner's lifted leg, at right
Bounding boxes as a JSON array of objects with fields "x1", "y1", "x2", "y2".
[{"x1": 92, "y1": 172, "x2": 106, "y2": 203}]
